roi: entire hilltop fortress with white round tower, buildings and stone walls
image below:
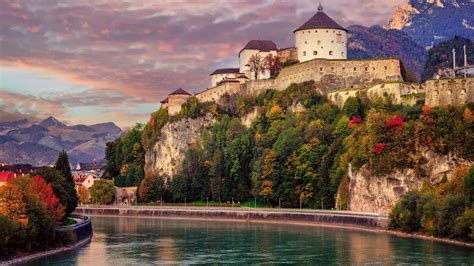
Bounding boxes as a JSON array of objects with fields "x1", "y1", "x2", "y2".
[{"x1": 161, "y1": 5, "x2": 474, "y2": 115}]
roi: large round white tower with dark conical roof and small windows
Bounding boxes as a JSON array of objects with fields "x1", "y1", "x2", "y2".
[{"x1": 293, "y1": 4, "x2": 347, "y2": 62}]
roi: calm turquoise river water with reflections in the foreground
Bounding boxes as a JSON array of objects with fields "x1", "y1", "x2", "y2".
[{"x1": 30, "y1": 217, "x2": 474, "y2": 266}]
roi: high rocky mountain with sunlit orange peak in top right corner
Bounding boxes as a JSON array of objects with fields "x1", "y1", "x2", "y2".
[{"x1": 386, "y1": 0, "x2": 474, "y2": 47}]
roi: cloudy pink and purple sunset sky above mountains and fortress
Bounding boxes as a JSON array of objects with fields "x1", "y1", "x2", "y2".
[{"x1": 0, "y1": 0, "x2": 407, "y2": 128}]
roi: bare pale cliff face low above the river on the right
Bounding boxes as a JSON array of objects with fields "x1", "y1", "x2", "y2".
[{"x1": 348, "y1": 152, "x2": 466, "y2": 214}]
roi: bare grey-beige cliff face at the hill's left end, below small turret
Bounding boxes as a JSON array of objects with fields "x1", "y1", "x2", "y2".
[{"x1": 145, "y1": 115, "x2": 214, "y2": 180}]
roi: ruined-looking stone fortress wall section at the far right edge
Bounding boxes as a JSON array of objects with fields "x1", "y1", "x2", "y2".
[{"x1": 424, "y1": 77, "x2": 474, "y2": 107}]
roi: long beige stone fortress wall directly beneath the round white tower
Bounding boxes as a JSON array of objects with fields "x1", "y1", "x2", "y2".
[{"x1": 275, "y1": 58, "x2": 402, "y2": 92}]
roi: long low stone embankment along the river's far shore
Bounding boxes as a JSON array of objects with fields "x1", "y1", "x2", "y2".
[{"x1": 76, "y1": 206, "x2": 388, "y2": 229}]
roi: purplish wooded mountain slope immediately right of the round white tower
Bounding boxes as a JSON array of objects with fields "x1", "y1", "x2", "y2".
[{"x1": 347, "y1": 25, "x2": 425, "y2": 73}]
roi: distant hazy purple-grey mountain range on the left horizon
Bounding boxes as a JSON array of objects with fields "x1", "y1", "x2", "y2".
[{"x1": 0, "y1": 117, "x2": 122, "y2": 166}]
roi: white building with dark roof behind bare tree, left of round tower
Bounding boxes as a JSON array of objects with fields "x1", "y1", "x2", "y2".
[{"x1": 239, "y1": 40, "x2": 278, "y2": 80}]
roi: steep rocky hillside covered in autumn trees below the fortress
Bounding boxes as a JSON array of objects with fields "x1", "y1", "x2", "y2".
[{"x1": 117, "y1": 82, "x2": 474, "y2": 213}]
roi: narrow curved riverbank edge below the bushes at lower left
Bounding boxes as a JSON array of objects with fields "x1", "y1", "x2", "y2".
[{"x1": 0, "y1": 215, "x2": 93, "y2": 266}]
